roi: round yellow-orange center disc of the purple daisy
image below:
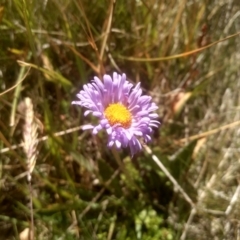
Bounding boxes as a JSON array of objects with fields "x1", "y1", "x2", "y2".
[{"x1": 104, "y1": 103, "x2": 132, "y2": 128}]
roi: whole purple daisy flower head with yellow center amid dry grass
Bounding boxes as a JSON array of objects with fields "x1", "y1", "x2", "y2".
[{"x1": 72, "y1": 73, "x2": 160, "y2": 156}]
